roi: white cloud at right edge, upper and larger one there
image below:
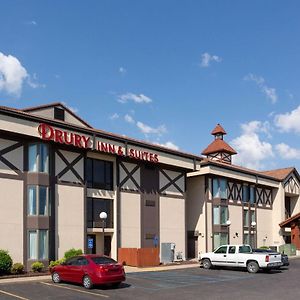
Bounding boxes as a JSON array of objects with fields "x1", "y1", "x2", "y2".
[{"x1": 274, "y1": 105, "x2": 300, "y2": 133}]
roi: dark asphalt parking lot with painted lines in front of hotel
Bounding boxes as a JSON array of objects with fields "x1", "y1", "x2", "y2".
[{"x1": 0, "y1": 259, "x2": 300, "y2": 300}]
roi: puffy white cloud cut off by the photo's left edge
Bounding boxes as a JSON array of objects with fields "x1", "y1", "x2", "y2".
[{"x1": 0, "y1": 52, "x2": 28, "y2": 97}]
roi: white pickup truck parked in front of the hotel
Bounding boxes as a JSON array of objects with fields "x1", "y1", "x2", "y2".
[{"x1": 199, "y1": 245, "x2": 282, "y2": 273}]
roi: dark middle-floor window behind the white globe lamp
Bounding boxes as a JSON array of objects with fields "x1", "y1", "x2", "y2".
[{"x1": 87, "y1": 198, "x2": 113, "y2": 228}]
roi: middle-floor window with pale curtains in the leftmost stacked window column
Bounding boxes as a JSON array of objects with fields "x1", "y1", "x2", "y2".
[{"x1": 27, "y1": 185, "x2": 49, "y2": 216}]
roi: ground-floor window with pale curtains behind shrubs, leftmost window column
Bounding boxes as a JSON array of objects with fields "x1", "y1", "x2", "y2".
[{"x1": 28, "y1": 229, "x2": 48, "y2": 260}]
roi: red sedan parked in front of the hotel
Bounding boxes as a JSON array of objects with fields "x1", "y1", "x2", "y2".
[{"x1": 50, "y1": 254, "x2": 125, "y2": 289}]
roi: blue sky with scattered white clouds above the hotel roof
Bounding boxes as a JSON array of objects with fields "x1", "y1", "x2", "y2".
[{"x1": 0, "y1": 0, "x2": 300, "y2": 169}]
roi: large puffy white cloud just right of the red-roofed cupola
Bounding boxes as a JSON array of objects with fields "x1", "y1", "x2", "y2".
[{"x1": 231, "y1": 121, "x2": 274, "y2": 169}]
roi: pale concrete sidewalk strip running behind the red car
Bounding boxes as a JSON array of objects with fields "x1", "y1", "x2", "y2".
[{"x1": 0, "y1": 262, "x2": 199, "y2": 285}]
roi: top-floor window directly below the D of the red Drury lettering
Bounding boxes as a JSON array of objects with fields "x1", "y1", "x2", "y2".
[{"x1": 28, "y1": 144, "x2": 49, "y2": 173}]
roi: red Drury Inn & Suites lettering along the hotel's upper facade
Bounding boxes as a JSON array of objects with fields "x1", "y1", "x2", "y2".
[{"x1": 38, "y1": 123, "x2": 158, "y2": 163}]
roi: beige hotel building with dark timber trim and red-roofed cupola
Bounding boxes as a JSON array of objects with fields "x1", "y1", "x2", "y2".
[{"x1": 0, "y1": 103, "x2": 300, "y2": 267}]
